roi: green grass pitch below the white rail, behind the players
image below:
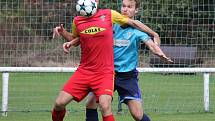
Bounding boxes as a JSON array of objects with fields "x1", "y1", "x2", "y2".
[{"x1": 0, "y1": 73, "x2": 215, "y2": 121}]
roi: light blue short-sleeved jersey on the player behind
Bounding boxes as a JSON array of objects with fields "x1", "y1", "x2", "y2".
[{"x1": 113, "y1": 24, "x2": 150, "y2": 72}]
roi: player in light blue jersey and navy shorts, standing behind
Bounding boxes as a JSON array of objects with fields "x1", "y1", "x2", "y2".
[{"x1": 80, "y1": 0, "x2": 172, "y2": 121}]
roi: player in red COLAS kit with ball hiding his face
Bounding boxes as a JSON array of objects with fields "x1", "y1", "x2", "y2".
[{"x1": 52, "y1": 0, "x2": 161, "y2": 121}]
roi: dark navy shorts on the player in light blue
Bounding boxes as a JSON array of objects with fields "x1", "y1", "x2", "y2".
[{"x1": 114, "y1": 70, "x2": 142, "y2": 104}]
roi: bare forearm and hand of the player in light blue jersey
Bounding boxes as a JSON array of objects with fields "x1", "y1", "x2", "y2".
[{"x1": 145, "y1": 40, "x2": 173, "y2": 63}]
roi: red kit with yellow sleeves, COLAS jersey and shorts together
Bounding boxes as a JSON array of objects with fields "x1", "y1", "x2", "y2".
[{"x1": 63, "y1": 9, "x2": 128, "y2": 102}]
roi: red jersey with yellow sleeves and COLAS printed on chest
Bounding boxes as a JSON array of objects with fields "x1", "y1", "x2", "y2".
[{"x1": 73, "y1": 9, "x2": 127, "y2": 72}]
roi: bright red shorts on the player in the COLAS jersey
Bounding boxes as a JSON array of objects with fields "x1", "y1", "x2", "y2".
[{"x1": 63, "y1": 70, "x2": 114, "y2": 102}]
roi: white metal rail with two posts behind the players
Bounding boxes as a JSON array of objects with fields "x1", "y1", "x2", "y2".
[{"x1": 0, "y1": 67, "x2": 215, "y2": 116}]
